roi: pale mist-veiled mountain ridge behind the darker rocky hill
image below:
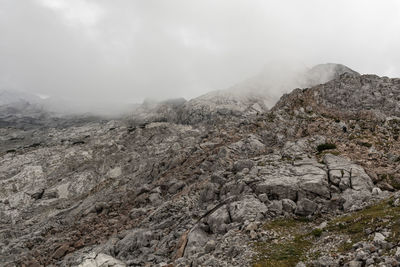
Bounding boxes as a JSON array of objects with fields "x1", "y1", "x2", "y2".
[{"x1": 133, "y1": 63, "x2": 359, "y2": 124}]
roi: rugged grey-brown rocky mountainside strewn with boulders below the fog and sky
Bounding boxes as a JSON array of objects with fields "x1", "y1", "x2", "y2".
[{"x1": 0, "y1": 65, "x2": 400, "y2": 267}]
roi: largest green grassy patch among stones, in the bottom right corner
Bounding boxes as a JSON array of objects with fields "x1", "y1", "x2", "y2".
[{"x1": 253, "y1": 199, "x2": 400, "y2": 267}]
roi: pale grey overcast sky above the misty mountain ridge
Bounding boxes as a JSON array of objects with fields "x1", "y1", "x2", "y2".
[{"x1": 0, "y1": 0, "x2": 400, "y2": 104}]
